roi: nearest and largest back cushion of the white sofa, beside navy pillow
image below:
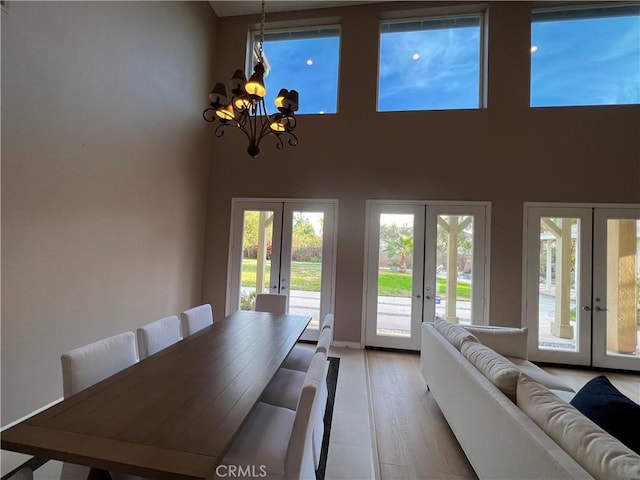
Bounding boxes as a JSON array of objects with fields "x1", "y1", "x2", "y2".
[{"x1": 517, "y1": 373, "x2": 640, "y2": 480}]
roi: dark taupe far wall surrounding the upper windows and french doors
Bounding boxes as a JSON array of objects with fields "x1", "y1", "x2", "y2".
[{"x1": 203, "y1": 2, "x2": 640, "y2": 342}]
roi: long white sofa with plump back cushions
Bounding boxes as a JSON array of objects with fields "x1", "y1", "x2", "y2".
[{"x1": 421, "y1": 320, "x2": 640, "y2": 480}]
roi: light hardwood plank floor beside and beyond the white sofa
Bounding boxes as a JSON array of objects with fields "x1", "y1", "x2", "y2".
[{"x1": 365, "y1": 350, "x2": 640, "y2": 480}]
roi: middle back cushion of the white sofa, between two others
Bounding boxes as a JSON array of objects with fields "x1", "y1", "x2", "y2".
[{"x1": 461, "y1": 342, "x2": 520, "y2": 403}]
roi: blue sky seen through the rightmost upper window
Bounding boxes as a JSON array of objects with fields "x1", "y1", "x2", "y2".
[{"x1": 531, "y1": 7, "x2": 640, "y2": 107}]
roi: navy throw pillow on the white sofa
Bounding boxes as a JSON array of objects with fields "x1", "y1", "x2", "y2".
[{"x1": 571, "y1": 375, "x2": 640, "y2": 453}]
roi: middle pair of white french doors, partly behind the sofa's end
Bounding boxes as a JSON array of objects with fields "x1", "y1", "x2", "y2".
[{"x1": 364, "y1": 201, "x2": 489, "y2": 350}]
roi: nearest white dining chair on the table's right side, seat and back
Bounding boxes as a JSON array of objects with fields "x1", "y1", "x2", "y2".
[{"x1": 222, "y1": 352, "x2": 326, "y2": 480}]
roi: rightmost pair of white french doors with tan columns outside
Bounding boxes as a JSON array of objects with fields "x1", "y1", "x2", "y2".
[{"x1": 524, "y1": 204, "x2": 640, "y2": 370}]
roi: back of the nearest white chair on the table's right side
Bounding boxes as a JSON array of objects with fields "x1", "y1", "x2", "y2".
[{"x1": 285, "y1": 352, "x2": 327, "y2": 478}]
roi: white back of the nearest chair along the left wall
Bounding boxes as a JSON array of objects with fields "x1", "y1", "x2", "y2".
[{"x1": 60, "y1": 332, "x2": 138, "y2": 398}]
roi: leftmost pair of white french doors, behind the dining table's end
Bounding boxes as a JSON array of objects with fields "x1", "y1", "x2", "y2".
[{"x1": 226, "y1": 199, "x2": 336, "y2": 340}]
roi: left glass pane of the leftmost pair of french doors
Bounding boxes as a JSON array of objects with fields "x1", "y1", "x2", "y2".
[{"x1": 240, "y1": 210, "x2": 274, "y2": 310}]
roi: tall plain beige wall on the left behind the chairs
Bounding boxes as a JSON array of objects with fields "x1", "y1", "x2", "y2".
[{"x1": 2, "y1": 2, "x2": 216, "y2": 425}]
